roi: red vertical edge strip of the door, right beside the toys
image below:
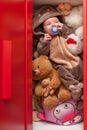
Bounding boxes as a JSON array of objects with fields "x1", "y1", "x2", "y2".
[{"x1": 24, "y1": 0, "x2": 33, "y2": 130}]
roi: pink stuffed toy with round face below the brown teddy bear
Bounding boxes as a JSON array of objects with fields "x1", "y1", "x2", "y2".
[{"x1": 37, "y1": 100, "x2": 83, "y2": 125}]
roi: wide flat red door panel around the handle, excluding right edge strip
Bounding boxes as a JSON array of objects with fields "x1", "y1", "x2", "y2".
[{"x1": 0, "y1": 0, "x2": 25, "y2": 130}]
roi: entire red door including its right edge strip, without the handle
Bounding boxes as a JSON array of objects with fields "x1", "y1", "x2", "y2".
[{"x1": 0, "y1": 0, "x2": 32, "y2": 130}]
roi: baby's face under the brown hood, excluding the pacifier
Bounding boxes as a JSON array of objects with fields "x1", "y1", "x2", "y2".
[{"x1": 43, "y1": 17, "x2": 63, "y2": 34}]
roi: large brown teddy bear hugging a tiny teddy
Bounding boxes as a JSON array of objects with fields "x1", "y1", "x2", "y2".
[{"x1": 32, "y1": 55, "x2": 71, "y2": 109}]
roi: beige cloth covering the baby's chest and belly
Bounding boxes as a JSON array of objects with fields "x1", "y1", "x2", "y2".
[{"x1": 50, "y1": 36, "x2": 80, "y2": 68}]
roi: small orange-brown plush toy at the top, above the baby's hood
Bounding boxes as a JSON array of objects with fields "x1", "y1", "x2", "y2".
[{"x1": 56, "y1": 2, "x2": 72, "y2": 16}]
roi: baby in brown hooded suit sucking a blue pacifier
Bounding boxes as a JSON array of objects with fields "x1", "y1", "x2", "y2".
[{"x1": 33, "y1": 6, "x2": 83, "y2": 100}]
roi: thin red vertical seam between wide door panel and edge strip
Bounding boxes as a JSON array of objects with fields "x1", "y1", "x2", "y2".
[{"x1": 24, "y1": 0, "x2": 27, "y2": 130}]
